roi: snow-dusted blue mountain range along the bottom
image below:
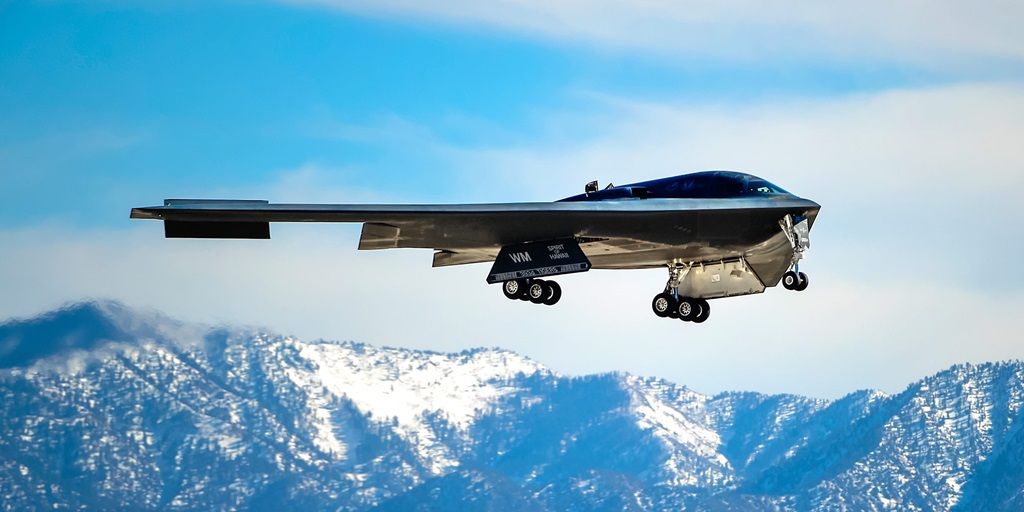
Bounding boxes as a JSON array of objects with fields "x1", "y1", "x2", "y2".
[{"x1": 0, "y1": 303, "x2": 1024, "y2": 511}]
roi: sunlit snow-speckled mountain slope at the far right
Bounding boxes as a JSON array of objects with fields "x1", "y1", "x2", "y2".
[{"x1": 812, "y1": 362, "x2": 1024, "y2": 510}]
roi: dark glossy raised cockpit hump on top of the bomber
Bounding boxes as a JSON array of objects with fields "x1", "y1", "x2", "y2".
[{"x1": 562, "y1": 171, "x2": 790, "y2": 201}]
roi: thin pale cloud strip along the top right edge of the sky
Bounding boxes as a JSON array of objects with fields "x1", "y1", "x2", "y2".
[{"x1": 284, "y1": 0, "x2": 1024, "y2": 68}]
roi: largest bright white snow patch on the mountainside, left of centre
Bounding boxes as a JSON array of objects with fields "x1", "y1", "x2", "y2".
[{"x1": 287, "y1": 340, "x2": 550, "y2": 475}]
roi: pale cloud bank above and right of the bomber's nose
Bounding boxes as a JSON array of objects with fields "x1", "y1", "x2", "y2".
[{"x1": 455, "y1": 85, "x2": 1024, "y2": 289}]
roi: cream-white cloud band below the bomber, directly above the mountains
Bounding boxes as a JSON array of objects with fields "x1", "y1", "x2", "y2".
[{"x1": 0, "y1": 222, "x2": 1024, "y2": 397}]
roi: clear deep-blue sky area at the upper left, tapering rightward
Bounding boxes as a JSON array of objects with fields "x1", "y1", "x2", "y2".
[{"x1": 0, "y1": 2, "x2": 958, "y2": 225}]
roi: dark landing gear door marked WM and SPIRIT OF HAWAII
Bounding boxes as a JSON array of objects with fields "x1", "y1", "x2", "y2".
[{"x1": 487, "y1": 239, "x2": 591, "y2": 285}]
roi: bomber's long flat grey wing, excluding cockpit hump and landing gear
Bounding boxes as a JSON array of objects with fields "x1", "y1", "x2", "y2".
[{"x1": 131, "y1": 196, "x2": 818, "y2": 266}]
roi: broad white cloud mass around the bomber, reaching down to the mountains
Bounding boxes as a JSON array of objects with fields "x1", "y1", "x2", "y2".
[{"x1": 0, "y1": 85, "x2": 1024, "y2": 397}]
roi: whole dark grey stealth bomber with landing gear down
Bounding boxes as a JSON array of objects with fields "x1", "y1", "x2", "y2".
[{"x1": 131, "y1": 171, "x2": 820, "y2": 323}]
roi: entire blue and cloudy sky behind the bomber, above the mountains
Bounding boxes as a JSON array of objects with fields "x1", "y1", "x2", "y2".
[{"x1": 0, "y1": 0, "x2": 1024, "y2": 396}]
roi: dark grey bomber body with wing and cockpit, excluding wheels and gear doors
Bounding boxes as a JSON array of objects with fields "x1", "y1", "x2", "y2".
[{"x1": 131, "y1": 171, "x2": 820, "y2": 286}]
